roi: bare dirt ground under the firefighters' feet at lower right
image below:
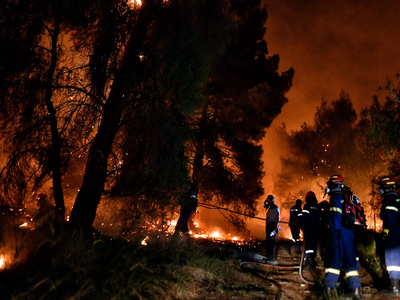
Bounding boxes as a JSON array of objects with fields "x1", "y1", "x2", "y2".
[{"x1": 236, "y1": 241, "x2": 400, "y2": 300}]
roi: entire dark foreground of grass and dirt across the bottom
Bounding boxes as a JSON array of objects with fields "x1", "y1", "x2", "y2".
[{"x1": 0, "y1": 230, "x2": 396, "y2": 300}]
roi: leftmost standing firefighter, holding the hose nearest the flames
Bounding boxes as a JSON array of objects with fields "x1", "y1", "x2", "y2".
[{"x1": 264, "y1": 195, "x2": 281, "y2": 265}]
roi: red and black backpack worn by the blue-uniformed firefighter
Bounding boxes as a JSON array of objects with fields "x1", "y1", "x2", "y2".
[{"x1": 342, "y1": 194, "x2": 366, "y2": 229}]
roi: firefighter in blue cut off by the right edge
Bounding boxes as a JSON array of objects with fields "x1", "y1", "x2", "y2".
[{"x1": 378, "y1": 176, "x2": 400, "y2": 296}]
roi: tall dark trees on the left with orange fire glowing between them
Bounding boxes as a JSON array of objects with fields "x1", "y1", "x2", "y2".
[{"x1": 0, "y1": 0, "x2": 294, "y2": 232}]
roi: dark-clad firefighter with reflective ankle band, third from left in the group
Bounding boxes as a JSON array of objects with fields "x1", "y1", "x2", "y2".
[{"x1": 303, "y1": 191, "x2": 319, "y2": 269}]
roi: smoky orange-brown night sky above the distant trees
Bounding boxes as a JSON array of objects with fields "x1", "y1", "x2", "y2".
[{"x1": 263, "y1": 0, "x2": 400, "y2": 129}]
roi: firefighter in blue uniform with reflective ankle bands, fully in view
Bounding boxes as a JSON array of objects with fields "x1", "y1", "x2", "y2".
[{"x1": 324, "y1": 175, "x2": 361, "y2": 299}]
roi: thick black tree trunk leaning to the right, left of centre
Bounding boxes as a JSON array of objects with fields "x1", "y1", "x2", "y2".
[{"x1": 70, "y1": 1, "x2": 152, "y2": 227}]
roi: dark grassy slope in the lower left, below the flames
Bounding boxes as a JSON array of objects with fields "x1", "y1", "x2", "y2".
[{"x1": 0, "y1": 223, "x2": 268, "y2": 299}]
